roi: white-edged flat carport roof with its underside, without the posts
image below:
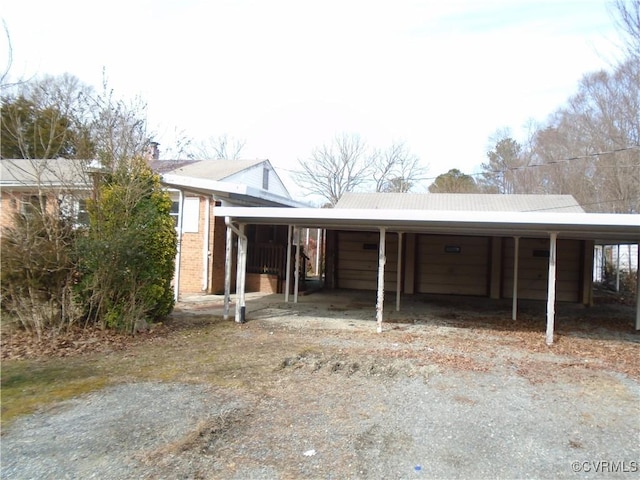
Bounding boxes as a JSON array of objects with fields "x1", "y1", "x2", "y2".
[{"x1": 214, "y1": 207, "x2": 640, "y2": 243}]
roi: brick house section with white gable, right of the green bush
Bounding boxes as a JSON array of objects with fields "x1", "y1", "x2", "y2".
[{"x1": 151, "y1": 160, "x2": 306, "y2": 298}]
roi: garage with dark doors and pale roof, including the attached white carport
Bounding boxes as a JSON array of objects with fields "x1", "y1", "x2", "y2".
[{"x1": 215, "y1": 193, "x2": 640, "y2": 343}]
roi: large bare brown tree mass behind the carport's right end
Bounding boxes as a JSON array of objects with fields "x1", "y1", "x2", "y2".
[{"x1": 532, "y1": 57, "x2": 640, "y2": 213}]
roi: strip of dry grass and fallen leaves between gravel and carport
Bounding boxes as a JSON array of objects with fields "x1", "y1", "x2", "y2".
[{"x1": 2, "y1": 294, "x2": 640, "y2": 430}]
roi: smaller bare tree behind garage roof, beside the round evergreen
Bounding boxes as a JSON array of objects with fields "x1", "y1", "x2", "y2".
[{"x1": 372, "y1": 142, "x2": 427, "y2": 193}]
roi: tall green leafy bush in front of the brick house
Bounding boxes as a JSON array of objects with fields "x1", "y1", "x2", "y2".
[{"x1": 76, "y1": 159, "x2": 177, "y2": 331}]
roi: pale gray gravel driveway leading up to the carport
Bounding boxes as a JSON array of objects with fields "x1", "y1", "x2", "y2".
[{"x1": 1, "y1": 290, "x2": 640, "y2": 480}]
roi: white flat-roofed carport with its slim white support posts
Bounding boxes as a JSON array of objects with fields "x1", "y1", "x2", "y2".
[{"x1": 215, "y1": 207, "x2": 640, "y2": 344}]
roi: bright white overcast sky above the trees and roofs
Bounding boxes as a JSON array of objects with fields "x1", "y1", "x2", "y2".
[{"x1": 0, "y1": 0, "x2": 618, "y2": 197}]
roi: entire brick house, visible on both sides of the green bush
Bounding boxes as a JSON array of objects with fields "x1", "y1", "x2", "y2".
[{"x1": 0, "y1": 158, "x2": 303, "y2": 299}]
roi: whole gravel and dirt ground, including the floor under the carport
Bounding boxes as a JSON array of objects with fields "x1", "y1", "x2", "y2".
[{"x1": 0, "y1": 292, "x2": 640, "y2": 479}]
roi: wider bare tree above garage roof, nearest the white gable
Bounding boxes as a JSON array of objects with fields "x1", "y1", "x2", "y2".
[{"x1": 294, "y1": 134, "x2": 377, "y2": 206}]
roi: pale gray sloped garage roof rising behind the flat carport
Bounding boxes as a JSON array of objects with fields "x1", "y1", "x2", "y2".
[{"x1": 335, "y1": 193, "x2": 585, "y2": 213}]
